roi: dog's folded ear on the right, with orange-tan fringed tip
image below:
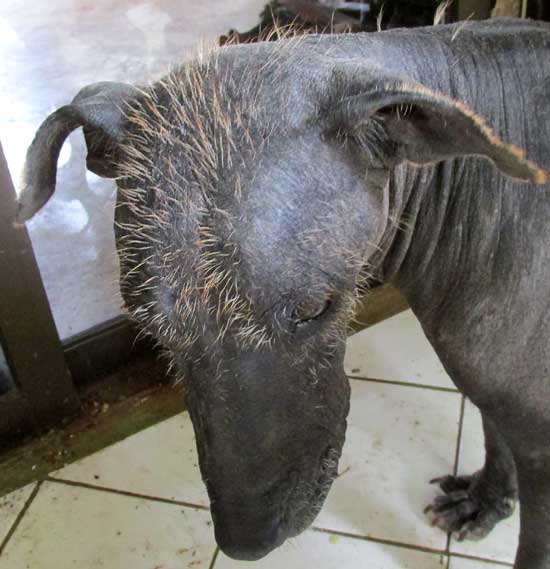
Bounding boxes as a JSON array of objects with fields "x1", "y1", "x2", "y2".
[{"x1": 324, "y1": 66, "x2": 548, "y2": 184}]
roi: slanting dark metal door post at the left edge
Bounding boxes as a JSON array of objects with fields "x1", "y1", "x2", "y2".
[{"x1": 0, "y1": 144, "x2": 80, "y2": 446}]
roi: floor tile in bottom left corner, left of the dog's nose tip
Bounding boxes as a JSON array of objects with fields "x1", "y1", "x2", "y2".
[{"x1": 2, "y1": 483, "x2": 215, "y2": 569}]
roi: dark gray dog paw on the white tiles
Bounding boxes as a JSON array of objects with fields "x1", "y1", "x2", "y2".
[{"x1": 424, "y1": 473, "x2": 516, "y2": 541}]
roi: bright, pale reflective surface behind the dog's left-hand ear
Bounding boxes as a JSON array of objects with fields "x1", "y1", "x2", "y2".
[{"x1": 0, "y1": 0, "x2": 265, "y2": 339}]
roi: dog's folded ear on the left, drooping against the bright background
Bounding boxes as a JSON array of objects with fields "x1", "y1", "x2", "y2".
[{"x1": 16, "y1": 81, "x2": 140, "y2": 223}]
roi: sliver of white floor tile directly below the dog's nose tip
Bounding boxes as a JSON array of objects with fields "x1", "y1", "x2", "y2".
[{"x1": 214, "y1": 531, "x2": 446, "y2": 569}]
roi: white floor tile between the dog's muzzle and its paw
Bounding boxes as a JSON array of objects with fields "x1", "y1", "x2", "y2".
[{"x1": 315, "y1": 380, "x2": 461, "y2": 549}]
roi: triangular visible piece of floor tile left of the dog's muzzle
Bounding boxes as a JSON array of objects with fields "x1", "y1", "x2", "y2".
[{"x1": 52, "y1": 413, "x2": 209, "y2": 506}]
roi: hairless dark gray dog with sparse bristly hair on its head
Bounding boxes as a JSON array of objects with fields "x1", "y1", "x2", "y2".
[{"x1": 18, "y1": 20, "x2": 550, "y2": 569}]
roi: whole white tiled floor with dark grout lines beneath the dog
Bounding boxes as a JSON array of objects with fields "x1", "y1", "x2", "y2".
[{"x1": 0, "y1": 312, "x2": 518, "y2": 569}]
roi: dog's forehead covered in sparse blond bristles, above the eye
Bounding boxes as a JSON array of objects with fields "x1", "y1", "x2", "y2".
[{"x1": 121, "y1": 48, "x2": 366, "y2": 346}]
